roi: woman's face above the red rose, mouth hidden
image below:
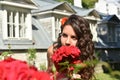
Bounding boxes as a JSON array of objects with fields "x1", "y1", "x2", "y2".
[{"x1": 61, "y1": 25, "x2": 78, "y2": 46}]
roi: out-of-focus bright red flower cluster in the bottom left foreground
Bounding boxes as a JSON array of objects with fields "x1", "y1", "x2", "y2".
[{"x1": 0, "y1": 57, "x2": 50, "y2": 80}]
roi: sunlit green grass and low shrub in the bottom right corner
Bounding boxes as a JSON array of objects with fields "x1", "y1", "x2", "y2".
[{"x1": 95, "y1": 62, "x2": 120, "y2": 80}]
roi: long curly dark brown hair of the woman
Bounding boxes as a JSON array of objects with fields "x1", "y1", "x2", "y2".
[{"x1": 55, "y1": 14, "x2": 95, "y2": 80}]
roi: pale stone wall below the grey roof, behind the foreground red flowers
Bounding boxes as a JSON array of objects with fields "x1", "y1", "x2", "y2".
[{"x1": 2, "y1": 50, "x2": 47, "y2": 69}]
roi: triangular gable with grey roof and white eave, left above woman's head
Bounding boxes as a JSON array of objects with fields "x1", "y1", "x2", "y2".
[{"x1": 32, "y1": 2, "x2": 76, "y2": 15}]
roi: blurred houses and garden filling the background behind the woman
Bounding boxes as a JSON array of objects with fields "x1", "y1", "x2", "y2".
[{"x1": 0, "y1": 0, "x2": 120, "y2": 80}]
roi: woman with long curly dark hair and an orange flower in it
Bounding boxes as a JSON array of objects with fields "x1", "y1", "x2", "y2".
[{"x1": 47, "y1": 15, "x2": 95, "y2": 80}]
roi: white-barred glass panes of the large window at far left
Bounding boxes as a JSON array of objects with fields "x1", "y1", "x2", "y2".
[{"x1": 7, "y1": 11, "x2": 27, "y2": 39}]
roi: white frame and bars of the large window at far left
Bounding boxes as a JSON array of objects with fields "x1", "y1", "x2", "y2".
[{"x1": 2, "y1": 9, "x2": 32, "y2": 40}]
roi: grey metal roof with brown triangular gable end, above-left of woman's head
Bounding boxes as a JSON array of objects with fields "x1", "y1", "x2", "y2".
[{"x1": 32, "y1": 0, "x2": 76, "y2": 13}]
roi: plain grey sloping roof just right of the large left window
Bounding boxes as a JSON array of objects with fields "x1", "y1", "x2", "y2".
[{"x1": 32, "y1": 18, "x2": 52, "y2": 49}]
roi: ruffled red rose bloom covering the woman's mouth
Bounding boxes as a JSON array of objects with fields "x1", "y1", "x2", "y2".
[{"x1": 52, "y1": 46, "x2": 81, "y2": 63}]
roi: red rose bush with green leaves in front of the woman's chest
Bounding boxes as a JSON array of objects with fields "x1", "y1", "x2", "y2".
[{"x1": 52, "y1": 46, "x2": 86, "y2": 80}]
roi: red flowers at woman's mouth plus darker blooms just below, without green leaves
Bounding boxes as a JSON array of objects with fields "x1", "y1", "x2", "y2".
[{"x1": 52, "y1": 46, "x2": 81, "y2": 71}]
